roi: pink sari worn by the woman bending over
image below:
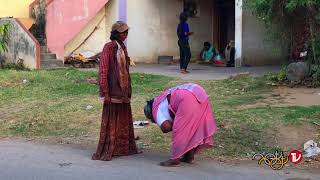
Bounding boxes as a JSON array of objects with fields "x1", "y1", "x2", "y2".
[{"x1": 153, "y1": 84, "x2": 217, "y2": 159}]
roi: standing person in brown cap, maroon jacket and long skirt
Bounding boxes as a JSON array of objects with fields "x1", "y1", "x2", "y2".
[{"x1": 92, "y1": 21, "x2": 138, "y2": 161}]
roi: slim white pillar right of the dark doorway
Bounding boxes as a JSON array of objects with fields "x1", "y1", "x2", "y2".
[{"x1": 235, "y1": 0, "x2": 242, "y2": 67}]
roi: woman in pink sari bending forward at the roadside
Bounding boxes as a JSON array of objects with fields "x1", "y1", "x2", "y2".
[{"x1": 144, "y1": 83, "x2": 217, "y2": 166}]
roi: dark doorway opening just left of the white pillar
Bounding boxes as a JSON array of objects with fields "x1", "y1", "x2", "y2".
[{"x1": 213, "y1": 0, "x2": 235, "y2": 53}]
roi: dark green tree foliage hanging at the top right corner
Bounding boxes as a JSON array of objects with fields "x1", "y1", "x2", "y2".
[{"x1": 243, "y1": 0, "x2": 320, "y2": 64}]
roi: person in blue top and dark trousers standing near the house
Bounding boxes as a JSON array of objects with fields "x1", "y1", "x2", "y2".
[{"x1": 177, "y1": 13, "x2": 193, "y2": 74}]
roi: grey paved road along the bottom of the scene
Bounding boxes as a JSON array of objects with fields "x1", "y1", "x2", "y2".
[{"x1": 0, "y1": 140, "x2": 320, "y2": 180}]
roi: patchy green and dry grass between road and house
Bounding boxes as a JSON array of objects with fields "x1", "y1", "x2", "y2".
[{"x1": 0, "y1": 68, "x2": 320, "y2": 156}]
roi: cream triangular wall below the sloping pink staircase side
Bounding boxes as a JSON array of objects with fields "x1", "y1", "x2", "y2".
[{"x1": 64, "y1": 0, "x2": 118, "y2": 57}]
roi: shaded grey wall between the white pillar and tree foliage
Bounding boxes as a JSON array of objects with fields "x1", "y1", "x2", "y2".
[{"x1": 242, "y1": 10, "x2": 286, "y2": 65}]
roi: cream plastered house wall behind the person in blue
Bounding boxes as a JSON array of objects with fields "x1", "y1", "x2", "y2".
[{"x1": 127, "y1": 0, "x2": 212, "y2": 63}]
